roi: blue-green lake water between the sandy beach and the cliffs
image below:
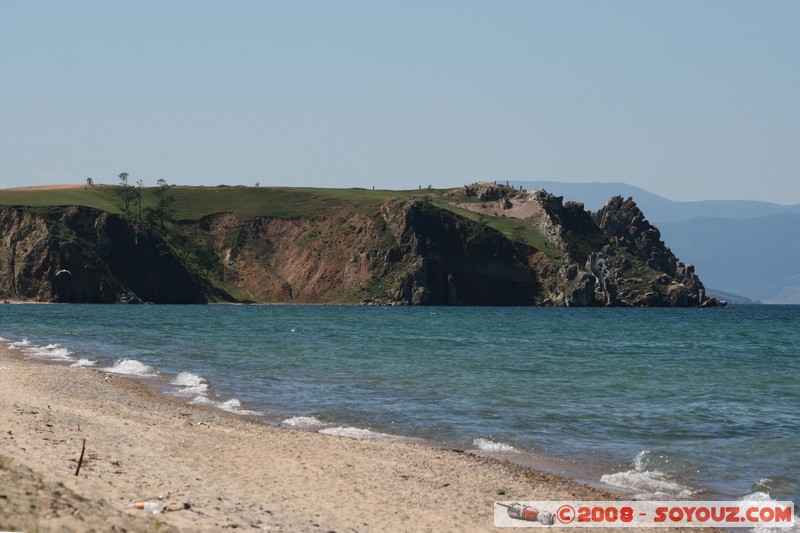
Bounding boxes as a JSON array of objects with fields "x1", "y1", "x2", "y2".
[{"x1": 0, "y1": 305, "x2": 800, "y2": 508}]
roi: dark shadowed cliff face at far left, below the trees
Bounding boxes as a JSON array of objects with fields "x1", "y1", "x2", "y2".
[{"x1": 0, "y1": 207, "x2": 205, "y2": 303}]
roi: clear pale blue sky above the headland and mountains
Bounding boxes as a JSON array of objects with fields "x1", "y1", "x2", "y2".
[{"x1": 0, "y1": 0, "x2": 800, "y2": 204}]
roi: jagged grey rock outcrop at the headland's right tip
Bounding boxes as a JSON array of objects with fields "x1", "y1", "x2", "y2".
[{"x1": 533, "y1": 190, "x2": 724, "y2": 307}]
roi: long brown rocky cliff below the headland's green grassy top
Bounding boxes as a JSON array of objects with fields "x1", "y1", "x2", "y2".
[{"x1": 0, "y1": 184, "x2": 718, "y2": 306}]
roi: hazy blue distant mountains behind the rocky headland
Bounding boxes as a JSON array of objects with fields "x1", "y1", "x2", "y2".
[{"x1": 511, "y1": 181, "x2": 800, "y2": 304}]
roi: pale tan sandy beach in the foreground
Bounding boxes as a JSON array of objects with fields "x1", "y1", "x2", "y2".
[{"x1": 0, "y1": 347, "x2": 712, "y2": 532}]
